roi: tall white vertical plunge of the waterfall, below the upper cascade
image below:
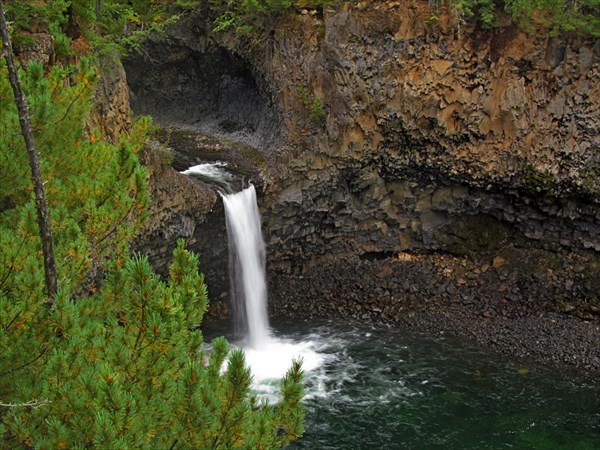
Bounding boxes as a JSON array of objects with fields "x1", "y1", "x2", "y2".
[{"x1": 222, "y1": 185, "x2": 269, "y2": 350}]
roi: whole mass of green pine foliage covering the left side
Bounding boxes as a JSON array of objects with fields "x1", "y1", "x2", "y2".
[{"x1": 0, "y1": 60, "x2": 303, "y2": 449}]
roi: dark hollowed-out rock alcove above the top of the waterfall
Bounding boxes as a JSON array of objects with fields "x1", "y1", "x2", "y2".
[{"x1": 125, "y1": 34, "x2": 281, "y2": 148}]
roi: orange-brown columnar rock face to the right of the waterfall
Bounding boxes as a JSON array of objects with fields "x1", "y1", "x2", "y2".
[{"x1": 256, "y1": 2, "x2": 600, "y2": 265}]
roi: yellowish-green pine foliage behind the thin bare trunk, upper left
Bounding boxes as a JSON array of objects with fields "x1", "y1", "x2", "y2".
[{"x1": 0, "y1": 59, "x2": 147, "y2": 426}]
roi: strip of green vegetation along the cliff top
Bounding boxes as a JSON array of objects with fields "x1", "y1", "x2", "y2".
[{"x1": 6, "y1": 0, "x2": 600, "y2": 67}]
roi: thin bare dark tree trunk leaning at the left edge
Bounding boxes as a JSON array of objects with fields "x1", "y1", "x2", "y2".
[{"x1": 0, "y1": 0, "x2": 58, "y2": 308}]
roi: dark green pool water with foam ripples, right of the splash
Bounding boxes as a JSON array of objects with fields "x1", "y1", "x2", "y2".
[{"x1": 266, "y1": 323, "x2": 600, "y2": 450}]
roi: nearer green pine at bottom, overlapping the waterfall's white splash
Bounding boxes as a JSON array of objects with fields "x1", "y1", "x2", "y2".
[{"x1": 0, "y1": 242, "x2": 303, "y2": 449}]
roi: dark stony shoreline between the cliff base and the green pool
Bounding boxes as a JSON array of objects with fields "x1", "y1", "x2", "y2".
[{"x1": 269, "y1": 251, "x2": 600, "y2": 377}]
